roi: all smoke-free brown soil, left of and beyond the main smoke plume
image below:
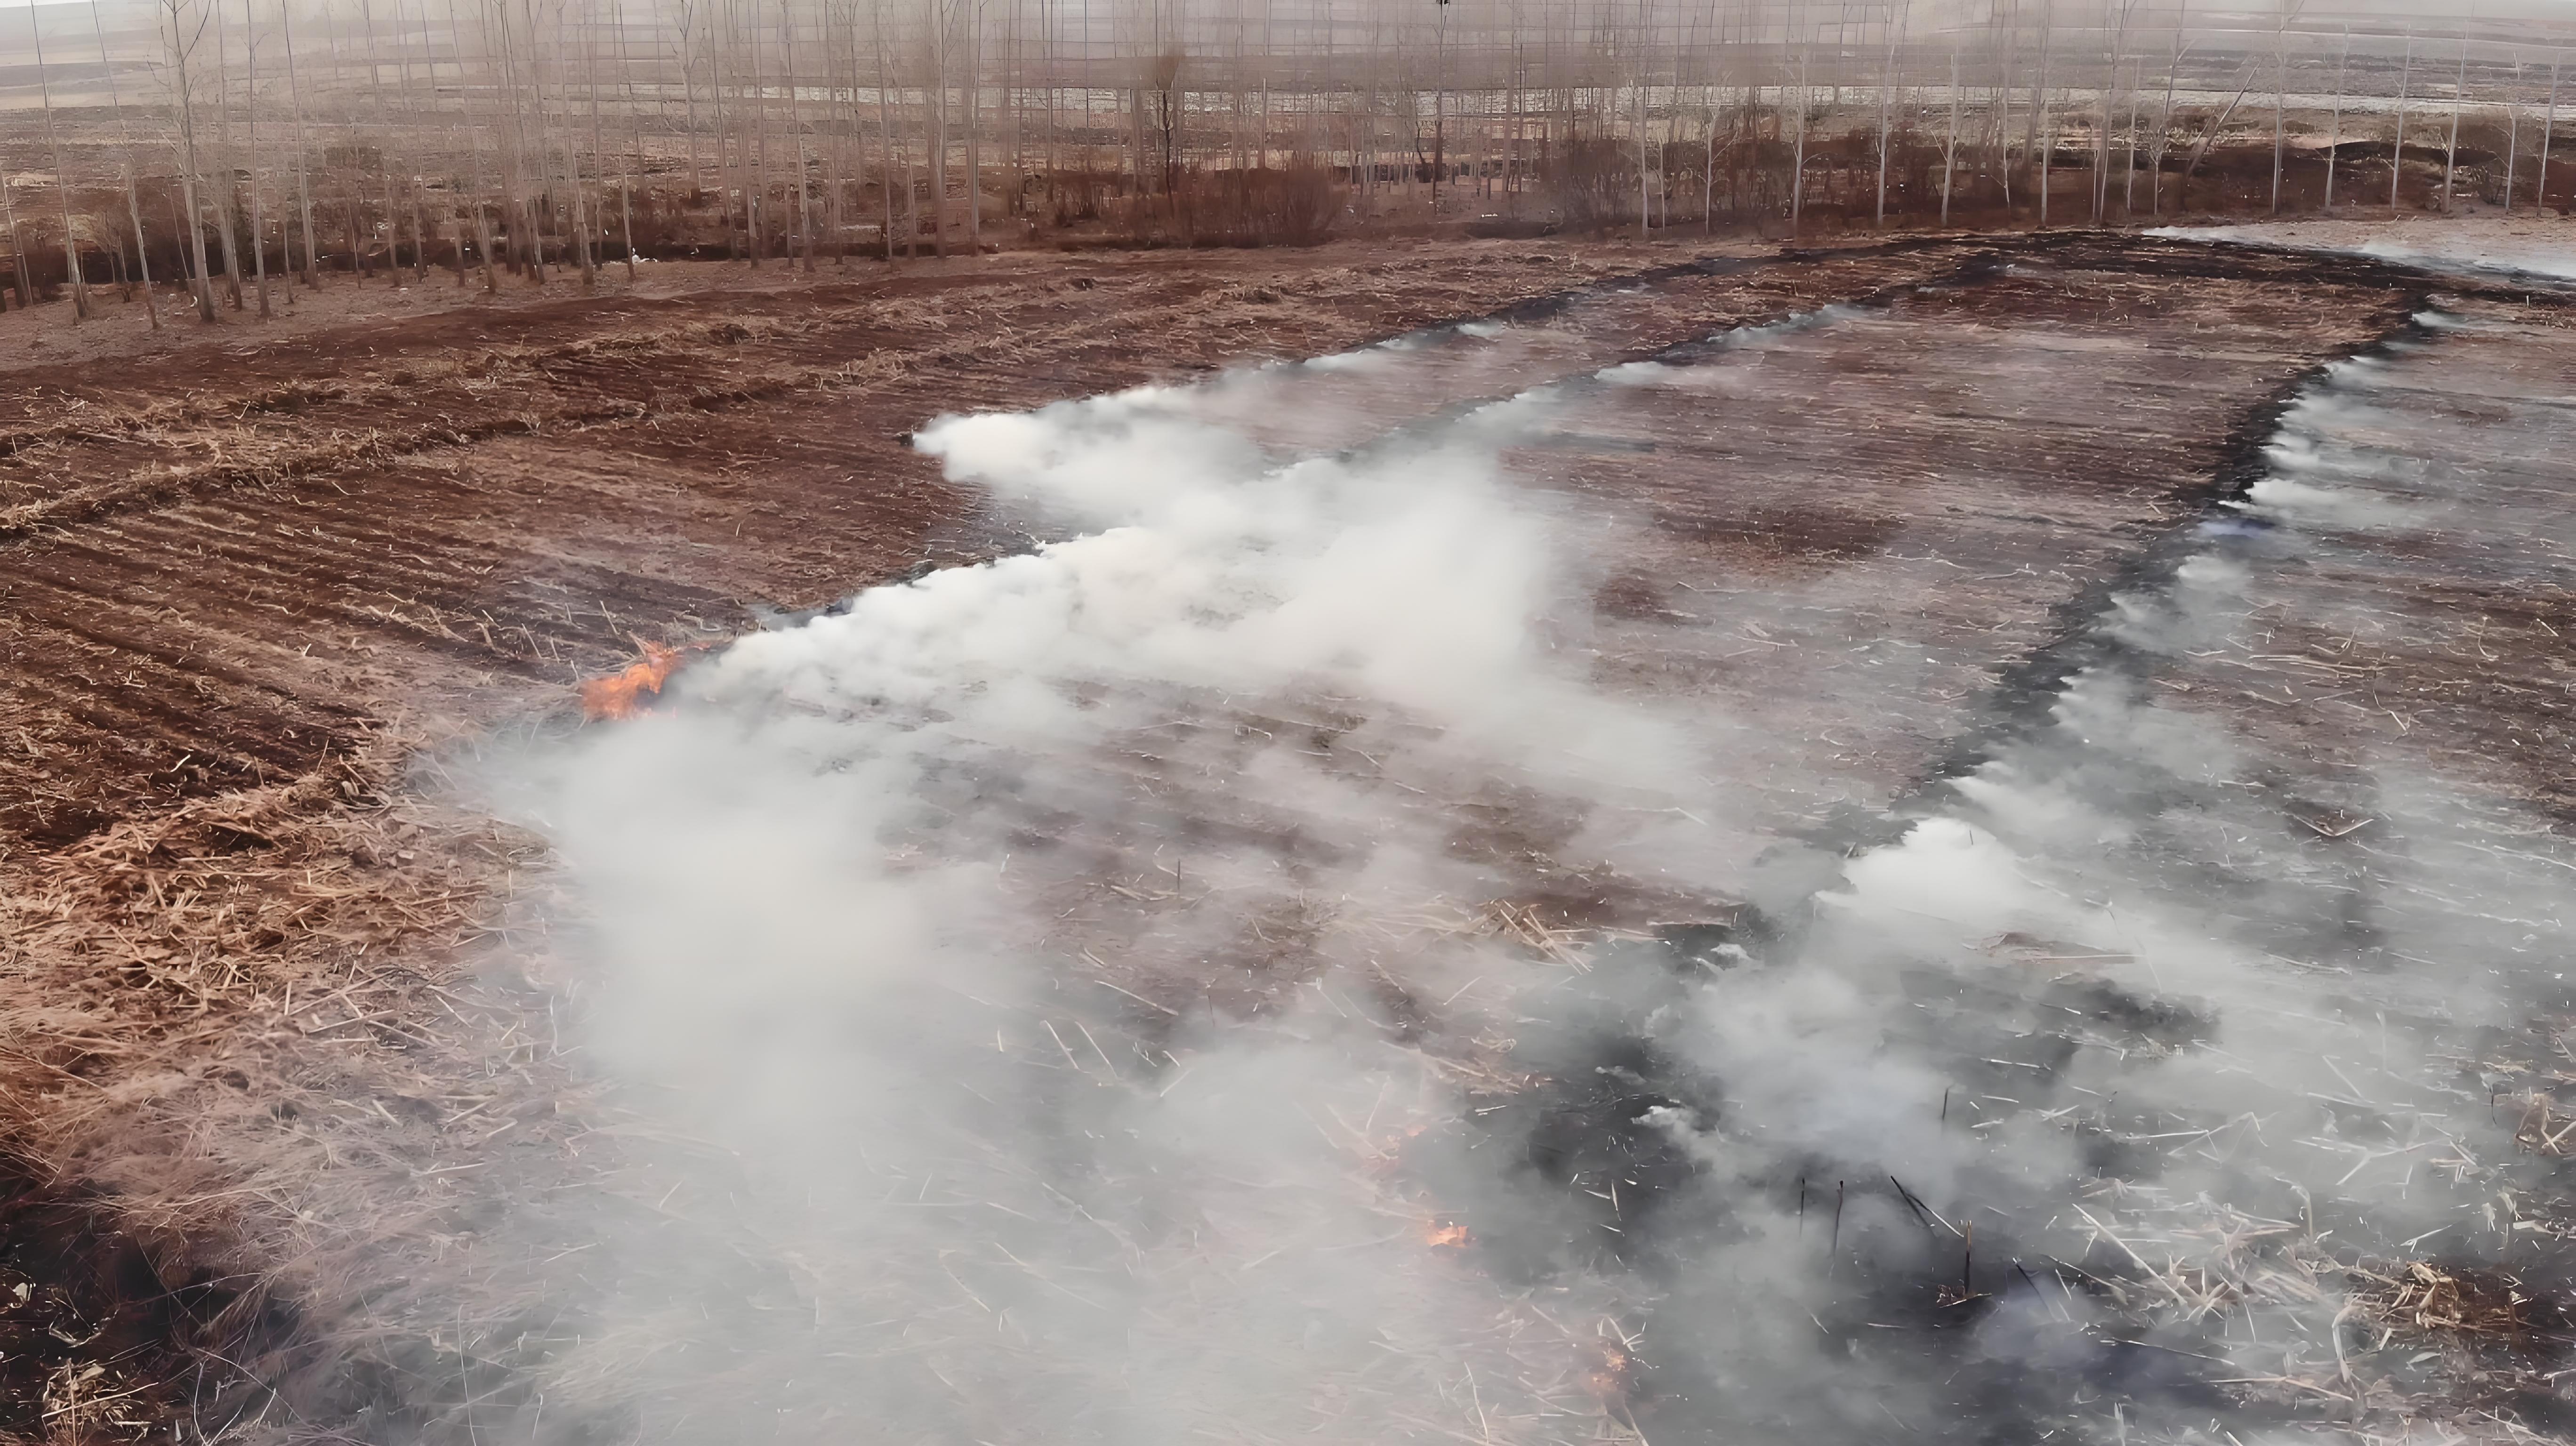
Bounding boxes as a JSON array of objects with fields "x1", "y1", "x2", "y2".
[{"x1": 0, "y1": 237, "x2": 2566, "y2": 1438}]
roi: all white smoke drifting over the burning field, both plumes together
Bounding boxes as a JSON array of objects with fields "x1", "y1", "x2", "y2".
[{"x1": 502, "y1": 299, "x2": 2566, "y2": 1444}]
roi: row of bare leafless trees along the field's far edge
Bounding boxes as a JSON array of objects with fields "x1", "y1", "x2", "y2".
[{"x1": 0, "y1": 0, "x2": 2576, "y2": 325}]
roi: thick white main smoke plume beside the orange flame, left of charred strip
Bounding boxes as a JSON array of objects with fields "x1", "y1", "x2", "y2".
[{"x1": 515, "y1": 337, "x2": 1710, "y2": 1441}]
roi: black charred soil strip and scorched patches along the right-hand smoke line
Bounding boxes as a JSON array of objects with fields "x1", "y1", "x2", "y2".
[{"x1": 1453, "y1": 265, "x2": 2576, "y2": 1441}]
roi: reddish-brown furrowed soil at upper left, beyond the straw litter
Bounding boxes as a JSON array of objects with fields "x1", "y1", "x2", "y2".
[{"x1": 0, "y1": 248, "x2": 1772, "y2": 848}]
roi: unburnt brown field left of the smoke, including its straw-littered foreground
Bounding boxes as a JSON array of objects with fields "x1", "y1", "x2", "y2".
[{"x1": 0, "y1": 234, "x2": 1916, "y2": 1425}]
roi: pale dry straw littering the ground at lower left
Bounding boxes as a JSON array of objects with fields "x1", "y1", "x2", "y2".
[{"x1": 0, "y1": 732, "x2": 590, "y2": 1438}]
